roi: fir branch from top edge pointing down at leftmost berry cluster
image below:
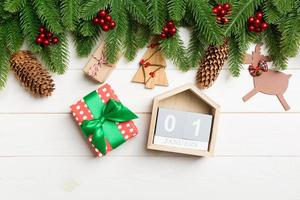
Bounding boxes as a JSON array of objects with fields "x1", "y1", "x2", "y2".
[{"x1": 33, "y1": 0, "x2": 64, "y2": 33}]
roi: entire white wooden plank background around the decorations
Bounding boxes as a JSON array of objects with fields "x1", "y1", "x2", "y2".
[{"x1": 0, "y1": 31, "x2": 300, "y2": 200}]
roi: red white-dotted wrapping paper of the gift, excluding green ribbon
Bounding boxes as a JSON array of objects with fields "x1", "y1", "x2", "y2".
[{"x1": 70, "y1": 84, "x2": 138, "y2": 156}]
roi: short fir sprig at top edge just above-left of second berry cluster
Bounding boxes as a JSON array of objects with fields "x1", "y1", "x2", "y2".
[{"x1": 81, "y1": 0, "x2": 109, "y2": 20}]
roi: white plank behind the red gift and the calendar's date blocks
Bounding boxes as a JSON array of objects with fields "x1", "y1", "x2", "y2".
[{"x1": 0, "y1": 114, "x2": 300, "y2": 157}]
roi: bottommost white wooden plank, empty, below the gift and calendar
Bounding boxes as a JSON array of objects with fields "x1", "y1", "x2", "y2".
[{"x1": 0, "y1": 157, "x2": 300, "y2": 200}]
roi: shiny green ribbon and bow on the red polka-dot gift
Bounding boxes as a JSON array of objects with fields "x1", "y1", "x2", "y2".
[{"x1": 81, "y1": 91, "x2": 138, "y2": 155}]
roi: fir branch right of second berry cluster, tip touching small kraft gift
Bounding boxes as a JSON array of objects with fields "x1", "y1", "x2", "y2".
[{"x1": 105, "y1": 0, "x2": 128, "y2": 63}]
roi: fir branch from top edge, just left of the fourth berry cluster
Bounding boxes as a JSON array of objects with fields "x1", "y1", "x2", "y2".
[{"x1": 188, "y1": 0, "x2": 224, "y2": 44}]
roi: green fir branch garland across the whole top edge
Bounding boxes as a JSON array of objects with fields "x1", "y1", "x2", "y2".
[{"x1": 0, "y1": 0, "x2": 300, "y2": 88}]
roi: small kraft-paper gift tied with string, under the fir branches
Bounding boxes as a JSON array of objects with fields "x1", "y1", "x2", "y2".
[{"x1": 83, "y1": 42, "x2": 116, "y2": 83}]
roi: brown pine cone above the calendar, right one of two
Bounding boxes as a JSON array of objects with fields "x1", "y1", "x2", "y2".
[{"x1": 196, "y1": 42, "x2": 228, "y2": 89}]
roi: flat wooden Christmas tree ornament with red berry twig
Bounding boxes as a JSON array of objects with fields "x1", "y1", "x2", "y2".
[{"x1": 132, "y1": 39, "x2": 168, "y2": 89}]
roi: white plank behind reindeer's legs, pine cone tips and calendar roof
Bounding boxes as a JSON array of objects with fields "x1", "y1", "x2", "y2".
[{"x1": 0, "y1": 70, "x2": 300, "y2": 113}]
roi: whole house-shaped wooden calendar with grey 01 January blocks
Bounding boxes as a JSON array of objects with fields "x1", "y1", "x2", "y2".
[{"x1": 147, "y1": 84, "x2": 220, "y2": 156}]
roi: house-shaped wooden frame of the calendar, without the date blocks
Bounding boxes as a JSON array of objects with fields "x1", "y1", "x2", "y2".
[{"x1": 147, "y1": 84, "x2": 220, "y2": 156}]
